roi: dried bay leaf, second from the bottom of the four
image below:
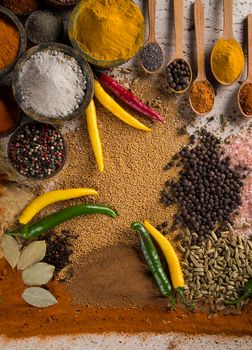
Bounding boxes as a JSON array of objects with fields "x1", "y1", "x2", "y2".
[{"x1": 22, "y1": 262, "x2": 55, "y2": 286}]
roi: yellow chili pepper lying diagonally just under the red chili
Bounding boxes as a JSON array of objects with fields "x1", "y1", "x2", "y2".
[{"x1": 94, "y1": 80, "x2": 151, "y2": 131}]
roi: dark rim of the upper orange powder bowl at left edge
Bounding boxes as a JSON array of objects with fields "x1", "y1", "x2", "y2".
[{"x1": 0, "y1": 6, "x2": 27, "y2": 78}]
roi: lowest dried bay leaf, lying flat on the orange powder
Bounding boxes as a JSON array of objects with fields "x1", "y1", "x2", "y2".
[{"x1": 22, "y1": 287, "x2": 57, "y2": 307}]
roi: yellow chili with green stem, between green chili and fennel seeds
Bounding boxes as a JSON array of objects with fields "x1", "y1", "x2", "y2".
[{"x1": 144, "y1": 220, "x2": 194, "y2": 308}]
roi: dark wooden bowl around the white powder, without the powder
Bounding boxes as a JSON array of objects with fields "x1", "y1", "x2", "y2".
[{"x1": 12, "y1": 43, "x2": 94, "y2": 124}]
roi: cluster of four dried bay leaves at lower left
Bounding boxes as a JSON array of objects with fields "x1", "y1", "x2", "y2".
[{"x1": 2, "y1": 234, "x2": 57, "y2": 307}]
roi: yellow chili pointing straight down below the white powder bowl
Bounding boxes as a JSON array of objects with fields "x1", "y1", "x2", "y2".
[{"x1": 86, "y1": 100, "x2": 104, "y2": 173}]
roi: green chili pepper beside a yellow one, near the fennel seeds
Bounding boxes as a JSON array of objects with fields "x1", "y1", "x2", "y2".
[{"x1": 131, "y1": 222, "x2": 175, "y2": 307}]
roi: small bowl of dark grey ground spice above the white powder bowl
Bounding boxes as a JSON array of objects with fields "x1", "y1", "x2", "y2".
[{"x1": 25, "y1": 10, "x2": 63, "y2": 44}]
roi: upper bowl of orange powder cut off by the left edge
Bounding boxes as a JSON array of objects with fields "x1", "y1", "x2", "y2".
[{"x1": 0, "y1": 6, "x2": 26, "y2": 77}]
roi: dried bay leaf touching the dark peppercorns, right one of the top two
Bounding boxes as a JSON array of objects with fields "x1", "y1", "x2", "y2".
[{"x1": 17, "y1": 241, "x2": 46, "y2": 270}]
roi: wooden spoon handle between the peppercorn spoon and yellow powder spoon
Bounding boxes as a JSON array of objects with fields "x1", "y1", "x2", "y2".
[{"x1": 194, "y1": 0, "x2": 206, "y2": 81}]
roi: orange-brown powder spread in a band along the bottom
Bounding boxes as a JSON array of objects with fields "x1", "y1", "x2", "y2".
[{"x1": 0, "y1": 259, "x2": 252, "y2": 338}]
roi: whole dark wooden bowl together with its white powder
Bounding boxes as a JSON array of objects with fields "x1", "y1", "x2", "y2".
[{"x1": 12, "y1": 43, "x2": 94, "y2": 124}]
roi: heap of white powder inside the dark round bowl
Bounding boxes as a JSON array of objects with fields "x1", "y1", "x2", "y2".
[{"x1": 20, "y1": 50, "x2": 87, "y2": 118}]
